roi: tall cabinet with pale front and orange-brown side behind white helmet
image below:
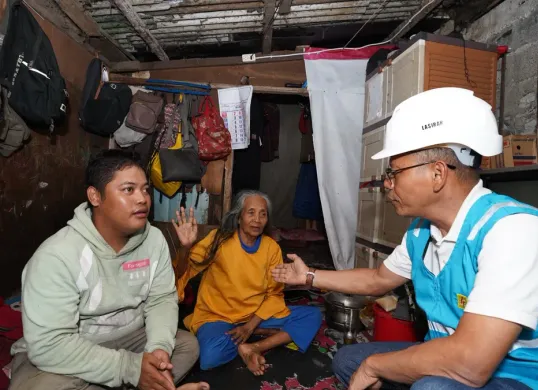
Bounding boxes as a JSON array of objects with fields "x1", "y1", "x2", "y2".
[{"x1": 356, "y1": 33, "x2": 498, "y2": 253}]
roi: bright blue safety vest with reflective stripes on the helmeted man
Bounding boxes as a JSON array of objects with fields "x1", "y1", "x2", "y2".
[{"x1": 406, "y1": 193, "x2": 538, "y2": 389}]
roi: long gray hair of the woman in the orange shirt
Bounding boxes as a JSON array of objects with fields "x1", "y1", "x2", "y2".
[{"x1": 203, "y1": 190, "x2": 273, "y2": 264}]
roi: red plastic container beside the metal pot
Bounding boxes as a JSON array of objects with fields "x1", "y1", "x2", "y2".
[{"x1": 374, "y1": 303, "x2": 418, "y2": 342}]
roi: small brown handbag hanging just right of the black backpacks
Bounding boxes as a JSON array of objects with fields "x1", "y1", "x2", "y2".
[{"x1": 125, "y1": 91, "x2": 164, "y2": 134}]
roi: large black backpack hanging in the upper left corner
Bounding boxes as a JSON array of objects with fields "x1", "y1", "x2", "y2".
[{"x1": 0, "y1": 1, "x2": 68, "y2": 133}]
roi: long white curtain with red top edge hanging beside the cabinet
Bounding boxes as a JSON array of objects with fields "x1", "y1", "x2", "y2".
[{"x1": 304, "y1": 48, "x2": 379, "y2": 269}]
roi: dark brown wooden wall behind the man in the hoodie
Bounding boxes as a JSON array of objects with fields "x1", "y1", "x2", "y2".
[{"x1": 0, "y1": 10, "x2": 108, "y2": 295}]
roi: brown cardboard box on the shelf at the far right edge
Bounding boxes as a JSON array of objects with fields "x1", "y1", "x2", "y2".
[{"x1": 502, "y1": 134, "x2": 538, "y2": 168}]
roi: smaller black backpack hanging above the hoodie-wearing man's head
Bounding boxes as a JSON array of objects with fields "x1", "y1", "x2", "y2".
[{"x1": 78, "y1": 58, "x2": 133, "y2": 137}]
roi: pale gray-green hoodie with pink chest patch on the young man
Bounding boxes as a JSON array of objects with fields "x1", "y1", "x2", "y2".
[{"x1": 12, "y1": 203, "x2": 178, "y2": 387}]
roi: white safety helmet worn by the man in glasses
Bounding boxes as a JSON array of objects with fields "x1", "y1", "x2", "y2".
[{"x1": 372, "y1": 88, "x2": 502, "y2": 166}]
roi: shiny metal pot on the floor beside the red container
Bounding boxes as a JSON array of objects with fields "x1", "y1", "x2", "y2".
[{"x1": 325, "y1": 292, "x2": 367, "y2": 332}]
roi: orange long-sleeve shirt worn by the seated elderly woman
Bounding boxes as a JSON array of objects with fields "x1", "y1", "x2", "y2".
[{"x1": 177, "y1": 230, "x2": 290, "y2": 333}]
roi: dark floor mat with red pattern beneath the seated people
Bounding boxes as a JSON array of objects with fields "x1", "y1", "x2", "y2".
[{"x1": 180, "y1": 291, "x2": 368, "y2": 390}]
